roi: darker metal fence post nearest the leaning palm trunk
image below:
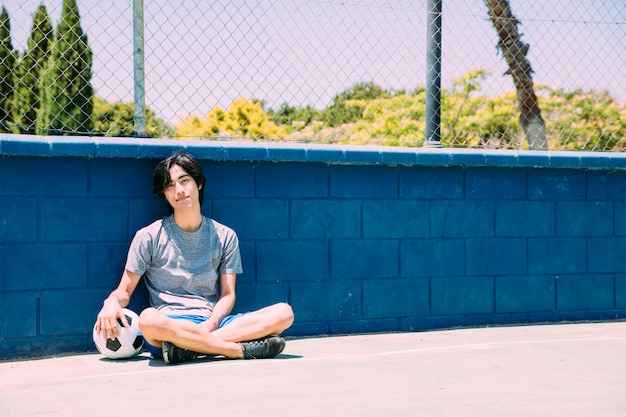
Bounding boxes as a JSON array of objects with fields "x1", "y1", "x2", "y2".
[{"x1": 423, "y1": 0, "x2": 443, "y2": 148}]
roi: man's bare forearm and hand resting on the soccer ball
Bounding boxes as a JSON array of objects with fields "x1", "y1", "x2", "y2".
[{"x1": 96, "y1": 270, "x2": 141, "y2": 340}]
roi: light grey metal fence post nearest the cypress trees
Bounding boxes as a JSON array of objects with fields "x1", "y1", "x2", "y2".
[{"x1": 133, "y1": 0, "x2": 146, "y2": 137}]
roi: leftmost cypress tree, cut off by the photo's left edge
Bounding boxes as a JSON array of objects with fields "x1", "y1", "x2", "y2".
[{"x1": 0, "y1": 7, "x2": 17, "y2": 132}]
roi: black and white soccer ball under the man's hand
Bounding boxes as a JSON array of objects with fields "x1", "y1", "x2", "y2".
[{"x1": 93, "y1": 308, "x2": 143, "y2": 359}]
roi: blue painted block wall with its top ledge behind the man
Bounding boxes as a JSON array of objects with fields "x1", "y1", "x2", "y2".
[{"x1": 0, "y1": 135, "x2": 626, "y2": 358}]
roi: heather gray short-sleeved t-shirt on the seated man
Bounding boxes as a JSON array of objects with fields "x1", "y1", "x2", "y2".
[{"x1": 126, "y1": 215, "x2": 243, "y2": 317}]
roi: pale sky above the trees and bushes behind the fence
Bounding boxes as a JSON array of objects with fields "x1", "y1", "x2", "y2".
[{"x1": 0, "y1": 0, "x2": 626, "y2": 123}]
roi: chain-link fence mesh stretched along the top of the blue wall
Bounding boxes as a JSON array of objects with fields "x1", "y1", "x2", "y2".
[{"x1": 0, "y1": 0, "x2": 626, "y2": 151}]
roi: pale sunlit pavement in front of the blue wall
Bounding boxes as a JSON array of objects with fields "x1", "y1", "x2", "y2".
[{"x1": 0, "y1": 322, "x2": 626, "y2": 417}]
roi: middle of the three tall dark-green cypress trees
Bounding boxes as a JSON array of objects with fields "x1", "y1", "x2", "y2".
[{"x1": 13, "y1": 5, "x2": 54, "y2": 134}]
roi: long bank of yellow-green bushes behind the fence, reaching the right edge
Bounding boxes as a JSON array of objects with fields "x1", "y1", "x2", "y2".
[{"x1": 176, "y1": 69, "x2": 626, "y2": 151}]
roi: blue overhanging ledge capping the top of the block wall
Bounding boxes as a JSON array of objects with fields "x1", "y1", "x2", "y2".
[{"x1": 0, "y1": 134, "x2": 626, "y2": 170}]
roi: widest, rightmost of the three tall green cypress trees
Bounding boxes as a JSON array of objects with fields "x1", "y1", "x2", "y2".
[{"x1": 36, "y1": 0, "x2": 94, "y2": 135}]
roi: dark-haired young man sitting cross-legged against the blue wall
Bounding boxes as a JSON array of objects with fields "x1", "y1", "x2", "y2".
[{"x1": 96, "y1": 154, "x2": 294, "y2": 364}]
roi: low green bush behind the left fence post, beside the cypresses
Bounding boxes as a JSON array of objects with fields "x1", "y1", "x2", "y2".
[{"x1": 93, "y1": 97, "x2": 172, "y2": 138}]
